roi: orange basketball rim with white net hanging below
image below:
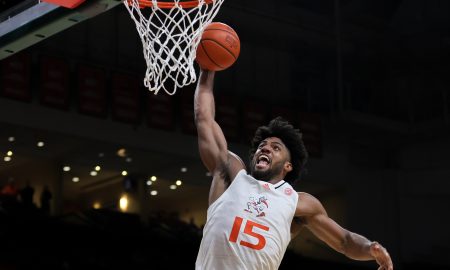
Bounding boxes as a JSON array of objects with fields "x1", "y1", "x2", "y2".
[{"x1": 123, "y1": 0, "x2": 224, "y2": 95}]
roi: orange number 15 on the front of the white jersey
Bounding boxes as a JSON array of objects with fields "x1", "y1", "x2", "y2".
[{"x1": 228, "y1": 217, "x2": 269, "y2": 250}]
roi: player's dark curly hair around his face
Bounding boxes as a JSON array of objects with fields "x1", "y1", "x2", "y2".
[{"x1": 250, "y1": 117, "x2": 308, "y2": 185}]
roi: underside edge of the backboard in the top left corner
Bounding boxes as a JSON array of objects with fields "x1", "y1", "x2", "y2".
[{"x1": 0, "y1": 0, "x2": 122, "y2": 60}]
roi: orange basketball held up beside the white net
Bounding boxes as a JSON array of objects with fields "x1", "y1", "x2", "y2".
[{"x1": 195, "y1": 22, "x2": 241, "y2": 71}]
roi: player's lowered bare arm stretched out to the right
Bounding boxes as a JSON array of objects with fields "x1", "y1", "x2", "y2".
[{"x1": 296, "y1": 193, "x2": 394, "y2": 270}]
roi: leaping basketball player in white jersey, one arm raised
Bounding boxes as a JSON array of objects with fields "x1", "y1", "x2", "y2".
[{"x1": 194, "y1": 71, "x2": 393, "y2": 270}]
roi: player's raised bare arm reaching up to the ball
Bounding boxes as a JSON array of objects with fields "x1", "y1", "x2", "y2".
[{"x1": 194, "y1": 70, "x2": 245, "y2": 203}]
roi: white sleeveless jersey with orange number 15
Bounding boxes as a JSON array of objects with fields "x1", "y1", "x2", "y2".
[{"x1": 195, "y1": 170, "x2": 298, "y2": 270}]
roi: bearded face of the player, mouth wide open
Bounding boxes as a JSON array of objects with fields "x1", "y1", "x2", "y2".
[{"x1": 251, "y1": 137, "x2": 290, "y2": 181}]
